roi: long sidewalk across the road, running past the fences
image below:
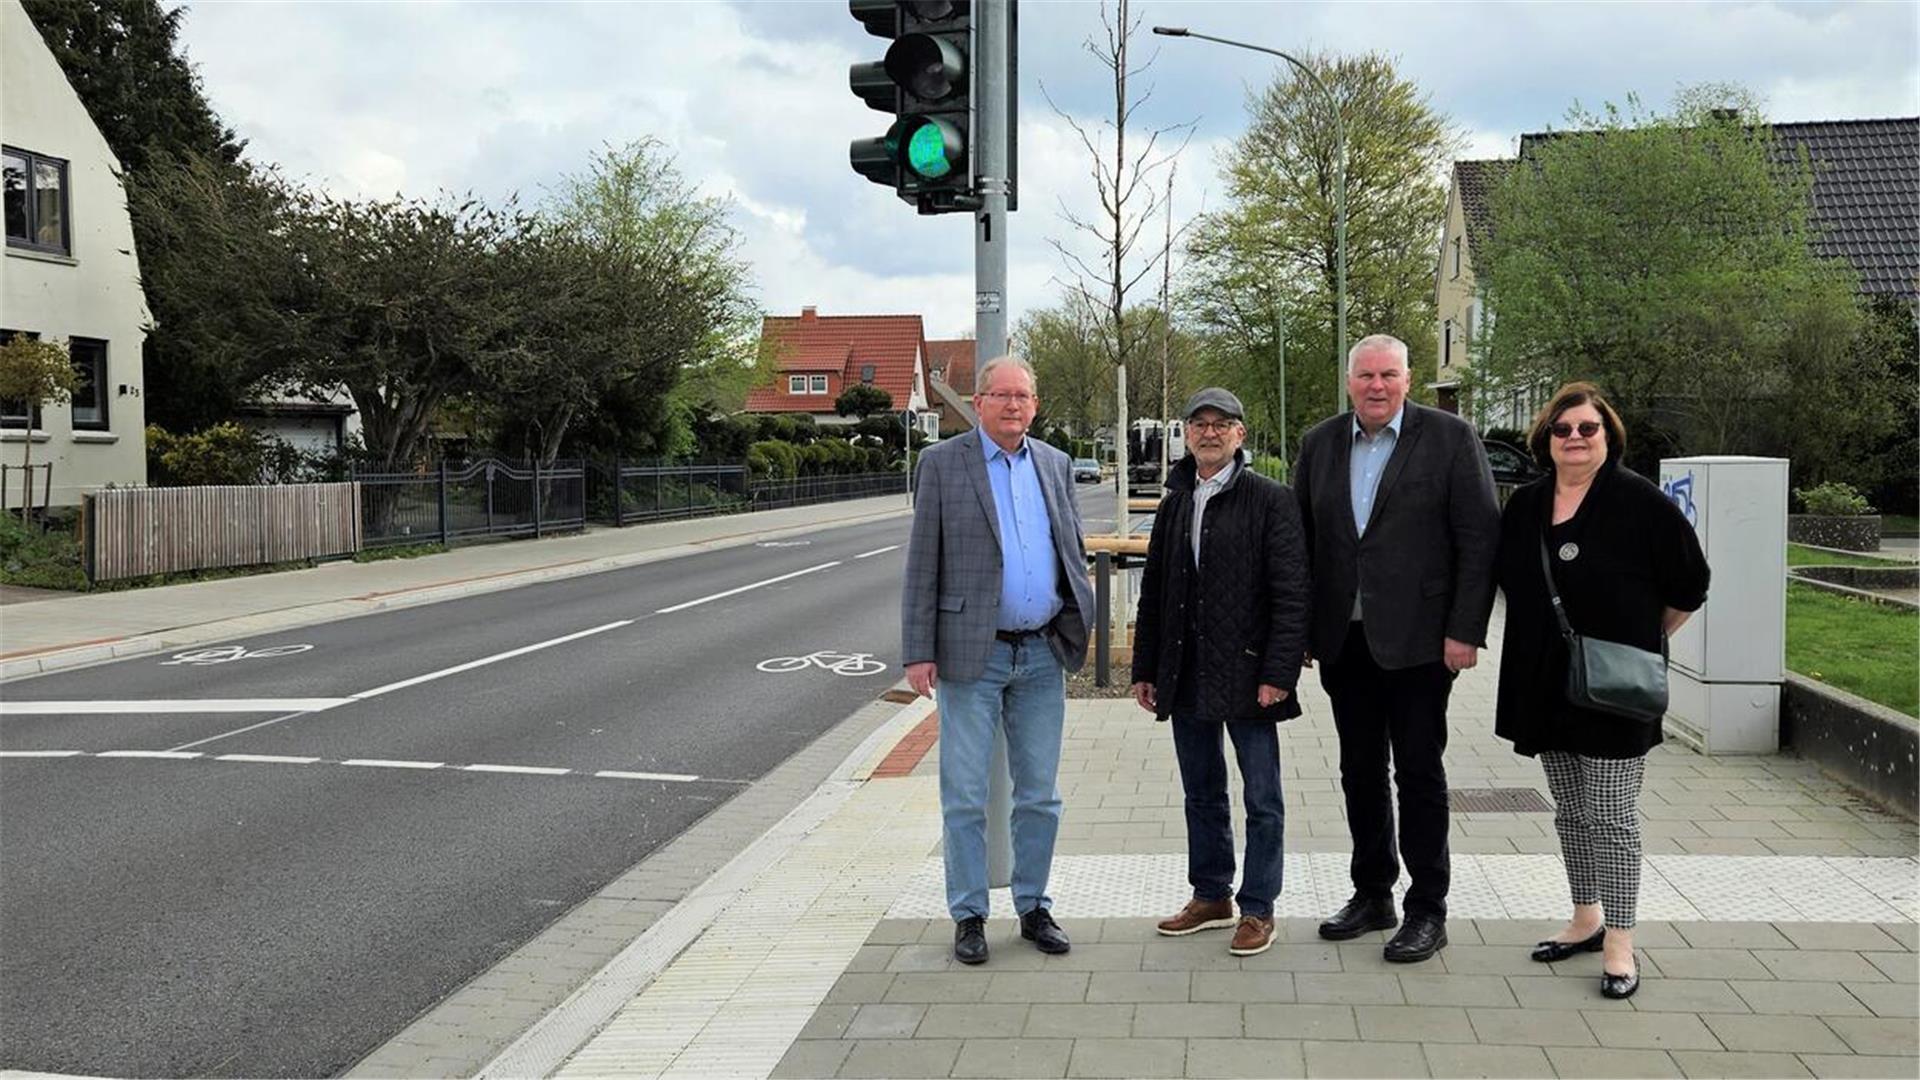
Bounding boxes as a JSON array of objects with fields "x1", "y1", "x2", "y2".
[{"x1": 0, "y1": 496, "x2": 908, "y2": 678}]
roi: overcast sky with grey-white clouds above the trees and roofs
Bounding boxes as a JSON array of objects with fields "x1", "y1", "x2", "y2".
[{"x1": 182, "y1": 0, "x2": 1920, "y2": 336}]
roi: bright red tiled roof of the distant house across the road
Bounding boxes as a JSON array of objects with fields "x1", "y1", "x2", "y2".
[{"x1": 747, "y1": 307, "x2": 925, "y2": 413}]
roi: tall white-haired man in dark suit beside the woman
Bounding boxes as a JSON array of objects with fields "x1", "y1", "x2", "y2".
[{"x1": 1294, "y1": 334, "x2": 1500, "y2": 963}]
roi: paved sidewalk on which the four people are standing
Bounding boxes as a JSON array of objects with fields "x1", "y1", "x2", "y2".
[{"x1": 510, "y1": 609, "x2": 1920, "y2": 1076}]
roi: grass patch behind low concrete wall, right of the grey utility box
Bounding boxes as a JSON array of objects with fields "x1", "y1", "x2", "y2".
[{"x1": 1788, "y1": 582, "x2": 1920, "y2": 717}]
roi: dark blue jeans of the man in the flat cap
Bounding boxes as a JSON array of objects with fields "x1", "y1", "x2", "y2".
[{"x1": 1173, "y1": 713, "x2": 1286, "y2": 919}]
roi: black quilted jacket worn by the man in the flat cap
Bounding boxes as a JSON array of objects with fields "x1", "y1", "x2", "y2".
[{"x1": 1133, "y1": 454, "x2": 1308, "y2": 721}]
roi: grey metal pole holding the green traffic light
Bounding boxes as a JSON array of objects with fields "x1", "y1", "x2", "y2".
[{"x1": 973, "y1": 0, "x2": 1016, "y2": 888}]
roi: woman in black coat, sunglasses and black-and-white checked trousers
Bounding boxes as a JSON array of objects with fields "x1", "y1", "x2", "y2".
[{"x1": 1494, "y1": 382, "x2": 1707, "y2": 997}]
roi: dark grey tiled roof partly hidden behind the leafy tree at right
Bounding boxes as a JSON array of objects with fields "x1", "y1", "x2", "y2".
[{"x1": 1512, "y1": 117, "x2": 1920, "y2": 300}]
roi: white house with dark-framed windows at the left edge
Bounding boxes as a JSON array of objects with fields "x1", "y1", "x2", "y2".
[{"x1": 0, "y1": 0, "x2": 150, "y2": 505}]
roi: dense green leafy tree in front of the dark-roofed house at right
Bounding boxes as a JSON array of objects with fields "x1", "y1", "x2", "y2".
[{"x1": 1473, "y1": 86, "x2": 1897, "y2": 482}]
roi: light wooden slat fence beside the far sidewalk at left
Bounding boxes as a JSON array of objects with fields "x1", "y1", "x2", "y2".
[{"x1": 81, "y1": 482, "x2": 363, "y2": 580}]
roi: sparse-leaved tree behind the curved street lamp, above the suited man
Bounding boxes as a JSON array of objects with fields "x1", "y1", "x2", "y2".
[{"x1": 1183, "y1": 54, "x2": 1459, "y2": 436}]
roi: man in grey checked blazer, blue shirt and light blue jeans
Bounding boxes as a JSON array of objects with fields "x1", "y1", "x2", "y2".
[{"x1": 900, "y1": 356, "x2": 1094, "y2": 965}]
